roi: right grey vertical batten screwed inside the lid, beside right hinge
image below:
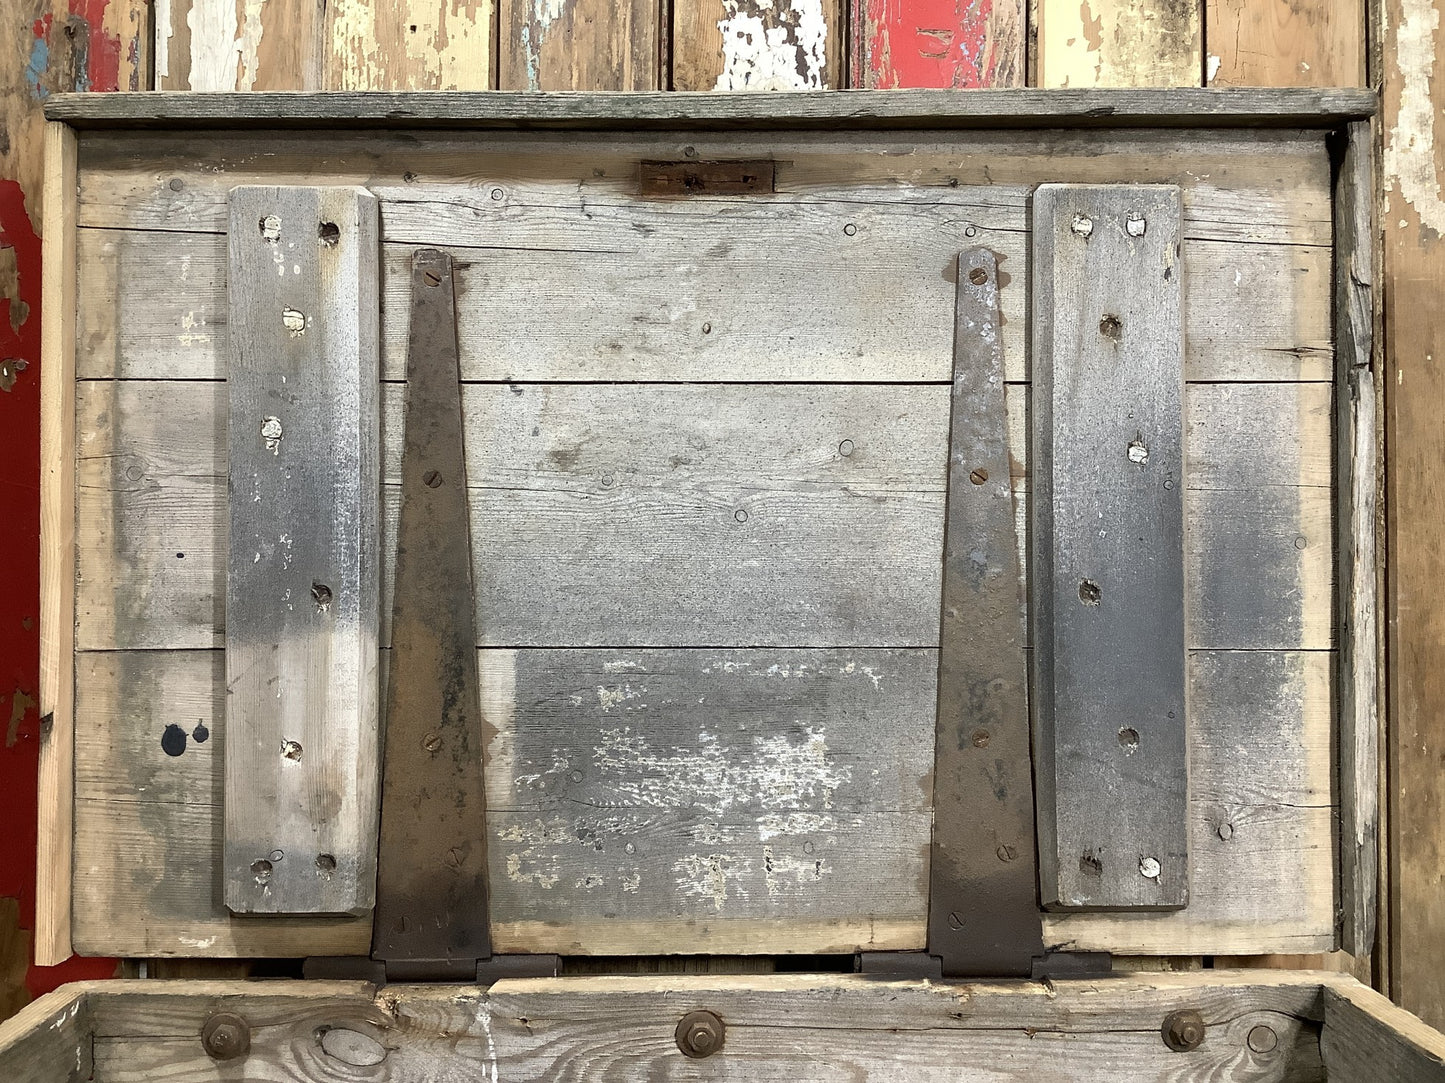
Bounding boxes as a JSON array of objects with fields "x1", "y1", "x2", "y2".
[{"x1": 1032, "y1": 185, "x2": 1189, "y2": 909}]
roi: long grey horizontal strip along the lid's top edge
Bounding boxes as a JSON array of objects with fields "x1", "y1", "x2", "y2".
[{"x1": 45, "y1": 88, "x2": 1377, "y2": 130}]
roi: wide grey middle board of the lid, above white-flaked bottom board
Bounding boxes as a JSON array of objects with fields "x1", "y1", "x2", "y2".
[{"x1": 67, "y1": 382, "x2": 1334, "y2": 649}]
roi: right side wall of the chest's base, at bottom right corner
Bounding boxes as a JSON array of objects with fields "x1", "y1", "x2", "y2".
[{"x1": 1319, "y1": 979, "x2": 1445, "y2": 1083}]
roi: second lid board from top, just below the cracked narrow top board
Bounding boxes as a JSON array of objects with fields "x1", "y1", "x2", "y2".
[{"x1": 78, "y1": 208, "x2": 1332, "y2": 380}]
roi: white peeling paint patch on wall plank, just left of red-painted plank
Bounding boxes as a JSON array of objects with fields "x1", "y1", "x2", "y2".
[{"x1": 714, "y1": 0, "x2": 828, "y2": 91}]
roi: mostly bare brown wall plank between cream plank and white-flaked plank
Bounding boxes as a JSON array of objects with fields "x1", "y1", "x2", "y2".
[{"x1": 497, "y1": 0, "x2": 666, "y2": 90}]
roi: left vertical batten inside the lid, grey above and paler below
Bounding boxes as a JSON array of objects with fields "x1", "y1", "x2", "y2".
[{"x1": 221, "y1": 187, "x2": 380, "y2": 914}]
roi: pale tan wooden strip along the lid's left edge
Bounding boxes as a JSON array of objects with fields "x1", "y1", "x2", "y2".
[{"x1": 35, "y1": 123, "x2": 77, "y2": 966}]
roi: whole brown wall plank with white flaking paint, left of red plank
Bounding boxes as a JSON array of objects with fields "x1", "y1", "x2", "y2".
[{"x1": 670, "y1": 0, "x2": 847, "y2": 91}]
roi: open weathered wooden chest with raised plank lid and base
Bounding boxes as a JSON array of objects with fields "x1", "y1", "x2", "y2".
[{"x1": 6, "y1": 91, "x2": 1442, "y2": 1079}]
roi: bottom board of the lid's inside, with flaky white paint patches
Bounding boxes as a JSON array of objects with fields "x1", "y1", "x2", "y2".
[{"x1": 67, "y1": 649, "x2": 1335, "y2": 957}]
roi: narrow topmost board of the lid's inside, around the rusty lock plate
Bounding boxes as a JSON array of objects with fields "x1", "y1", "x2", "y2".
[{"x1": 70, "y1": 130, "x2": 1332, "y2": 246}]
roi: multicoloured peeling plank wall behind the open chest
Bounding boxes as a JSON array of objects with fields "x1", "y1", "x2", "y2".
[{"x1": 0, "y1": 0, "x2": 1445, "y2": 1025}]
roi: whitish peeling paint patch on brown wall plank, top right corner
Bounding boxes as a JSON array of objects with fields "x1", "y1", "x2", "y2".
[{"x1": 1384, "y1": 0, "x2": 1445, "y2": 234}]
